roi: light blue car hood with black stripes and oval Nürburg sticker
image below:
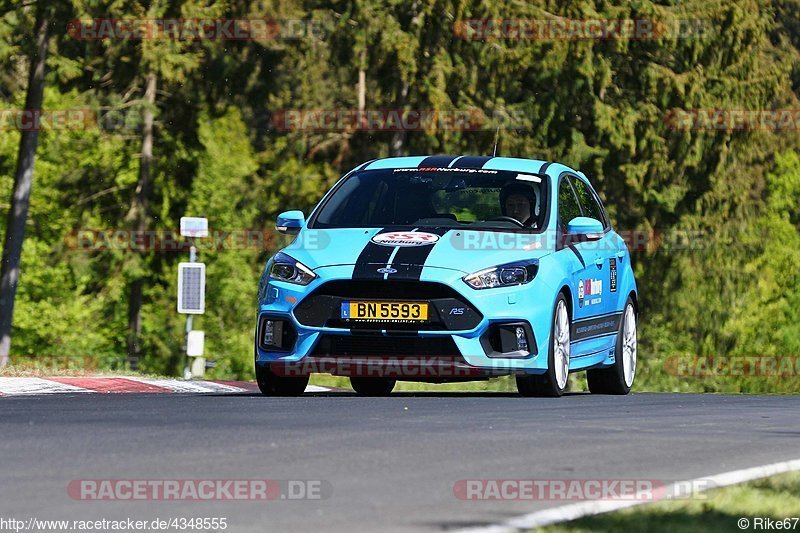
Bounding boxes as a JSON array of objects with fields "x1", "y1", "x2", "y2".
[{"x1": 283, "y1": 228, "x2": 553, "y2": 274}]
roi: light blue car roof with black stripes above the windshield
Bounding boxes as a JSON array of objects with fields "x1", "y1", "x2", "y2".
[{"x1": 355, "y1": 155, "x2": 586, "y2": 184}]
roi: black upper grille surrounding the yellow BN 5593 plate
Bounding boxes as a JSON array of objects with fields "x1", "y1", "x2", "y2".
[{"x1": 294, "y1": 280, "x2": 483, "y2": 331}]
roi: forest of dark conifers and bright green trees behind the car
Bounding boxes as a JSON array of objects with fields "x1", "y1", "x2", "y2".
[{"x1": 0, "y1": 0, "x2": 800, "y2": 391}]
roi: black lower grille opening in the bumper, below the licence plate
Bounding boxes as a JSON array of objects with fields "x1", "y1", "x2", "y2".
[{"x1": 311, "y1": 335, "x2": 461, "y2": 358}]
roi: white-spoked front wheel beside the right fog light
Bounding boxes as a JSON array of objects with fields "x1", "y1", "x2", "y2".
[{"x1": 517, "y1": 293, "x2": 572, "y2": 398}]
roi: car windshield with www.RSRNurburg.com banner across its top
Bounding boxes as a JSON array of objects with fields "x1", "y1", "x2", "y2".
[{"x1": 309, "y1": 168, "x2": 547, "y2": 232}]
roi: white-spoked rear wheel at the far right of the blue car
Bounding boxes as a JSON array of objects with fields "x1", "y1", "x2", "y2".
[{"x1": 586, "y1": 297, "x2": 638, "y2": 394}]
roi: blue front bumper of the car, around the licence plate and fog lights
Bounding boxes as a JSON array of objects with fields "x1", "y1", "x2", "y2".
[{"x1": 256, "y1": 265, "x2": 555, "y2": 375}]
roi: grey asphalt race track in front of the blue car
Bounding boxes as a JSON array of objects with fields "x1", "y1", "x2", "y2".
[{"x1": 0, "y1": 392, "x2": 800, "y2": 532}]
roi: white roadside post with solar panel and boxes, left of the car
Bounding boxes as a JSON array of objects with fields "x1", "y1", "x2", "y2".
[{"x1": 178, "y1": 217, "x2": 208, "y2": 379}]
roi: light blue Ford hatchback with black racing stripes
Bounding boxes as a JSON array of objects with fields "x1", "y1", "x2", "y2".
[{"x1": 255, "y1": 156, "x2": 639, "y2": 397}]
